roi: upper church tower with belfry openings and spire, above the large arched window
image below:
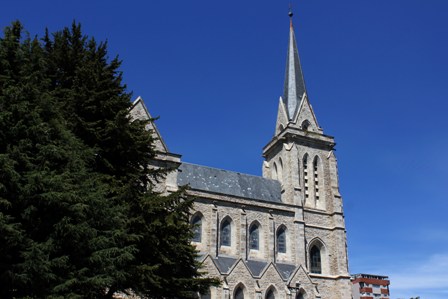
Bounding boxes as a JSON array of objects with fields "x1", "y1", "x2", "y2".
[{"x1": 263, "y1": 12, "x2": 338, "y2": 212}]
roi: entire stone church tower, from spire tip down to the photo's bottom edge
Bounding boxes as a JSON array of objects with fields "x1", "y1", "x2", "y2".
[{"x1": 263, "y1": 12, "x2": 351, "y2": 298}]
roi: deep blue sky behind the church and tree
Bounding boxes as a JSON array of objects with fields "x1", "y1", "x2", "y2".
[{"x1": 0, "y1": 0, "x2": 448, "y2": 299}]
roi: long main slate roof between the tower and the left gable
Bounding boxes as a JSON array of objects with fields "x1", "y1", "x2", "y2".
[{"x1": 177, "y1": 163, "x2": 281, "y2": 202}]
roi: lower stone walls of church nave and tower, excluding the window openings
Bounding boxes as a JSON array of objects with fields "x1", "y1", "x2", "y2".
[{"x1": 189, "y1": 190, "x2": 350, "y2": 299}]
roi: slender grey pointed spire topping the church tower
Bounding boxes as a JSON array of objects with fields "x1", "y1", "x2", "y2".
[{"x1": 283, "y1": 10, "x2": 306, "y2": 120}]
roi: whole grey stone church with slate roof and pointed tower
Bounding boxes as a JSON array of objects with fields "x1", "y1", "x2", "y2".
[{"x1": 131, "y1": 13, "x2": 352, "y2": 299}]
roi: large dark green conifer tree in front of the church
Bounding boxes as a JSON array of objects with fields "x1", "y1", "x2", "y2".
[{"x1": 0, "y1": 22, "x2": 216, "y2": 298}]
